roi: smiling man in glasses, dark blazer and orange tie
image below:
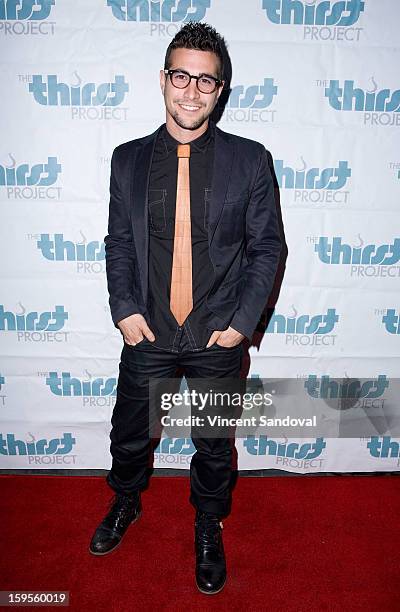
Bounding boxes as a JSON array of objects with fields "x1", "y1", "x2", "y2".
[{"x1": 90, "y1": 23, "x2": 281, "y2": 594}]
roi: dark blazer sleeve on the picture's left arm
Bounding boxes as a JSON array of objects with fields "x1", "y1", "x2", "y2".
[{"x1": 104, "y1": 147, "x2": 141, "y2": 327}]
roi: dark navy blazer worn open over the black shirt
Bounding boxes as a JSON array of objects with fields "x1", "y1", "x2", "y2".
[{"x1": 104, "y1": 127, "x2": 282, "y2": 340}]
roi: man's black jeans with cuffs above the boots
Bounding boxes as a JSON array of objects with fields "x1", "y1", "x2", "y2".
[{"x1": 107, "y1": 338, "x2": 243, "y2": 517}]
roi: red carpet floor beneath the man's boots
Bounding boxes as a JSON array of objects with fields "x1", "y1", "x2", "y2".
[{"x1": 0, "y1": 476, "x2": 400, "y2": 612}]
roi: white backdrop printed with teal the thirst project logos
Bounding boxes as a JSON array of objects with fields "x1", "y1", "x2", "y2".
[{"x1": 0, "y1": 0, "x2": 400, "y2": 473}]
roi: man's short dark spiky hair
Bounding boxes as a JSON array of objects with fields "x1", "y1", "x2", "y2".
[{"x1": 164, "y1": 21, "x2": 226, "y2": 79}]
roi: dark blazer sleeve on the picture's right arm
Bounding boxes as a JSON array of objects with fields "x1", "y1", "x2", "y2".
[{"x1": 230, "y1": 145, "x2": 282, "y2": 340}]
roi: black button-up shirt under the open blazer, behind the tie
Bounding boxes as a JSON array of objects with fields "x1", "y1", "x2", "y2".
[{"x1": 148, "y1": 123, "x2": 222, "y2": 352}]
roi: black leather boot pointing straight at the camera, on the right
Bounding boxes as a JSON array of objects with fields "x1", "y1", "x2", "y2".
[{"x1": 195, "y1": 511, "x2": 226, "y2": 595}]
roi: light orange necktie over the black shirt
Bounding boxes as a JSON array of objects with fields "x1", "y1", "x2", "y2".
[{"x1": 170, "y1": 144, "x2": 193, "y2": 325}]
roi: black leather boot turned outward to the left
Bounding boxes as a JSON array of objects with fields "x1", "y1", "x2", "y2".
[{"x1": 89, "y1": 492, "x2": 142, "y2": 555}]
